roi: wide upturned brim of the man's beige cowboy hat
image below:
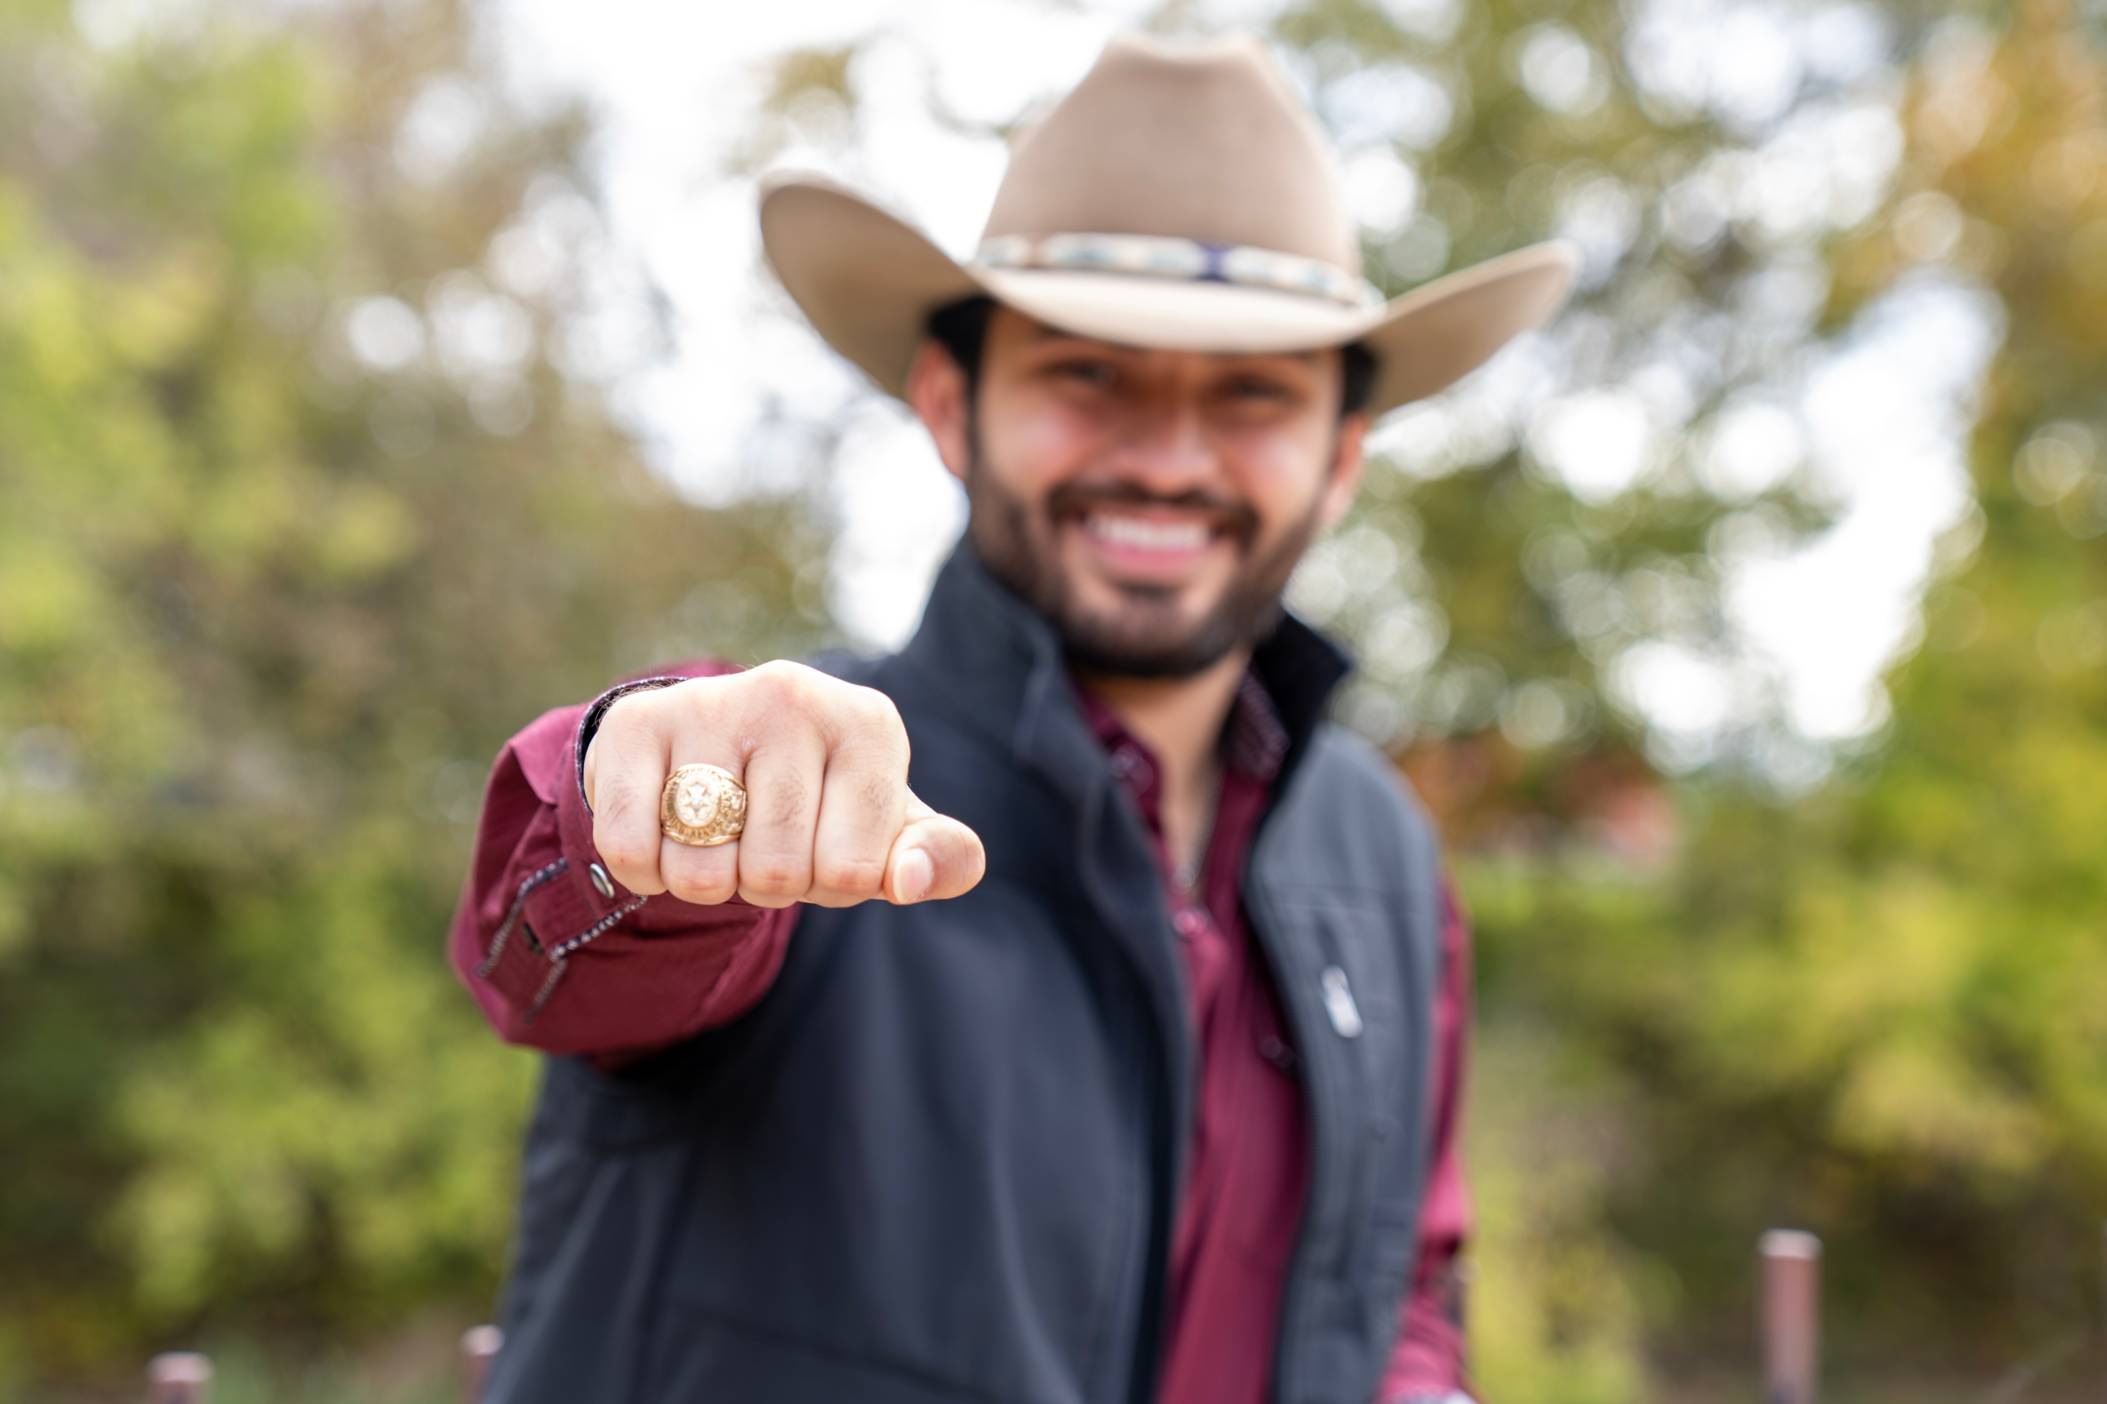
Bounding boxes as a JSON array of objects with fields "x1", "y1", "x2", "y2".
[{"x1": 761, "y1": 173, "x2": 1578, "y2": 415}]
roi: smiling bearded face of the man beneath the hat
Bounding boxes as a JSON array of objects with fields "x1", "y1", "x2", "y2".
[{"x1": 910, "y1": 306, "x2": 1365, "y2": 677}]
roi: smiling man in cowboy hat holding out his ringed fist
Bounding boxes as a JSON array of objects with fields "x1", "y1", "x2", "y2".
[{"x1": 451, "y1": 40, "x2": 1572, "y2": 1404}]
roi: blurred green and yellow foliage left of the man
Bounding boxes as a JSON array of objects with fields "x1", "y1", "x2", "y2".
[{"x1": 0, "y1": 0, "x2": 826, "y2": 1393}]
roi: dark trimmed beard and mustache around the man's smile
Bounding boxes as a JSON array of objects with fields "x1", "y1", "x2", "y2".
[{"x1": 965, "y1": 404, "x2": 1323, "y2": 679}]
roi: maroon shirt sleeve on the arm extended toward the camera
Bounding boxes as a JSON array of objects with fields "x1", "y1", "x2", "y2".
[{"x1": 447, "y1": 660, "x2": 799, "y2": 1069}]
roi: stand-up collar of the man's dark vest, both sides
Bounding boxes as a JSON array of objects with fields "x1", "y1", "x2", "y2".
[{"x1": 902, "y1": 535, "x2": 1353, "y2": 778}]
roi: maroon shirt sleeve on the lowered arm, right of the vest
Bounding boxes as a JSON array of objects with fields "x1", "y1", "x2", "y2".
[{"x1": 1376, "y1": 875, "x2": 1471, "y2": 1404}]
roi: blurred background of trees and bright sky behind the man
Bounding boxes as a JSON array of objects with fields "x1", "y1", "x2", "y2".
[{"x1": 0, "y1": 0, "x2": 2107, "y2": 1404}]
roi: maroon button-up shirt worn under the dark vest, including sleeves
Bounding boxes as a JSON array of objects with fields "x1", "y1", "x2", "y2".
[{"x1": 449, "y1": 660, "x2": 1471, "y2": 1404}]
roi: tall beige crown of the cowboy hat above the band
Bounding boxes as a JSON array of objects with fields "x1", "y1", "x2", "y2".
[{"x1": 982, "y1": 36, "x2": 1361, "y2": 276}]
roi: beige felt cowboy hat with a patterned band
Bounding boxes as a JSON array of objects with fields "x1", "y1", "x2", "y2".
[{"x1": 761, "y1": 36, "x2": 1578, "y2": 415}]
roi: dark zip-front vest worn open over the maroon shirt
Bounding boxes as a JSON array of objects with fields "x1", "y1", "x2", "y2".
[{"x1": 487, "y1": 544, "x2": 1441, "y2": 1404}]
